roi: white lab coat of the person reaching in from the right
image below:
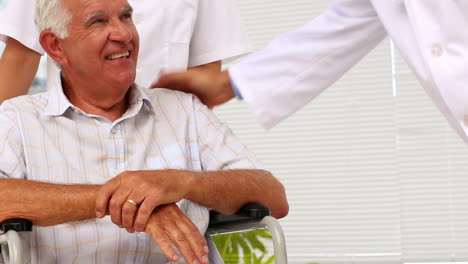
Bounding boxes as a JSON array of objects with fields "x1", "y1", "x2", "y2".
[{"x1": 229, "y1": 0, "x2": 468, "y2": 143}]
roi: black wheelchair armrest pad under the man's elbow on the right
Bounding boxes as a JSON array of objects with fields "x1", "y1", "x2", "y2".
[{"x1": 209, "y1": 204, "x2": 270, "y2": 227}]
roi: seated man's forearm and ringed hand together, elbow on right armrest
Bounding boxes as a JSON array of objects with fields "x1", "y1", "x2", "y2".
[{"x1": 96, "y1": 170, "x2": 289, "y2": 232}]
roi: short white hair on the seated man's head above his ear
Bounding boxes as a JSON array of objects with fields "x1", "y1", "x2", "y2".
[{"x1": 34, "y1": 0, "x2": 72, "y2": 39}]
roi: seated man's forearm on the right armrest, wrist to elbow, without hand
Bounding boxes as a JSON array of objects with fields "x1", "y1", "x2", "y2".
[{"x1": 186, "y1": 170, "x2": 289, "y2": 218}]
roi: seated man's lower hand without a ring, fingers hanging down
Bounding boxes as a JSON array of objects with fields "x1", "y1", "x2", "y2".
[{"x1": 145, "y1": 204, "x2": 208, "y2": 264}]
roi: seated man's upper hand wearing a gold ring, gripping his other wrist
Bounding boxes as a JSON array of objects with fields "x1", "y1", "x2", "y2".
[{"x1": 96, "y1": 170, "x2": 191, "y2": 233}]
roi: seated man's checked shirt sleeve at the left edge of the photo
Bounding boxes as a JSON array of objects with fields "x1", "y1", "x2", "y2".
[{"x1": 0, "y1": 101, "x2": 26, "y2": 179}]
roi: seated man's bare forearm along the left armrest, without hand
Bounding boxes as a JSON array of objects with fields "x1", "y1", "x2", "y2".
[{"x1": 0, "y1": 179, "x2": 101, "y2": 226}]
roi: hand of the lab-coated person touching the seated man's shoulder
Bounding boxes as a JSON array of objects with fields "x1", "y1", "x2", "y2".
[{"x1": 151, "y1": 71, "x2": 235, "y2": 108}]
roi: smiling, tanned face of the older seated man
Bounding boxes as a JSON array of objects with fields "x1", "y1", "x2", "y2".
[{"x1": 55, "y1": 0, "x2": 139, "y2": 100}]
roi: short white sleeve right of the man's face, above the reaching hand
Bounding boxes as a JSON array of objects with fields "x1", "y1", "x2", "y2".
[{"x1": 188, "y1": 0, "x2": 252, "y2": 67}]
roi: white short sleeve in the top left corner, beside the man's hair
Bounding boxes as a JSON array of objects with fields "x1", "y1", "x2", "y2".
[{"x1": 0, "y1": 0, "x2": 44, "y2": 55}]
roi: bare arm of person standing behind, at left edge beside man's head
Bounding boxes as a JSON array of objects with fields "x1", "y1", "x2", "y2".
[{"x1": 0, "y1": 38, "x2": 41, "y2": 104}]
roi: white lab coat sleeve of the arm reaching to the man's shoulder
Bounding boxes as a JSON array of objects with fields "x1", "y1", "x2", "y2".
[{"x1": 229, "y1": 0, "x2": 386, "y2": 128}]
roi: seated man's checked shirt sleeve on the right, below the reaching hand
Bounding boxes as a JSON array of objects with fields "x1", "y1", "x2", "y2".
[{"x1": 193, "y1": 96, "x2": 263, "y2": 171}]
